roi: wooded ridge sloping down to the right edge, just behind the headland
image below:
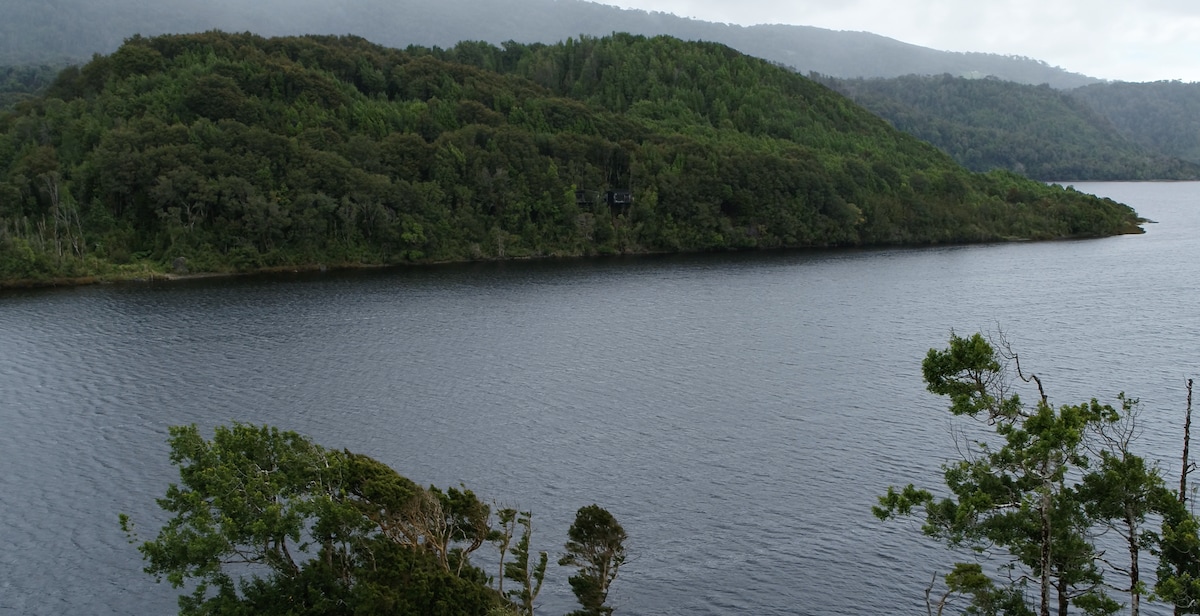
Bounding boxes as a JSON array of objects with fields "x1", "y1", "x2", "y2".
[{"x1": 827, "y1": 76, "x2": 1200, "y2": 180}]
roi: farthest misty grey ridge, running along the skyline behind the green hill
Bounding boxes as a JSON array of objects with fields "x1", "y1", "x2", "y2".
[{"x1": 0, "y1": 0, "x2": 1097, "y2": 88}]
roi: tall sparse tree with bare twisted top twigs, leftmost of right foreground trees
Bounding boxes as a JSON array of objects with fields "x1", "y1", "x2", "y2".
[{"x1": 874, "y1": 334, "x2": 1117, "y2": 616}]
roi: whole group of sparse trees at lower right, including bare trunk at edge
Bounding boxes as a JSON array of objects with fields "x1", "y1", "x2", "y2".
[{"x1": 874, "y1": 334, "x2": 1200, "y2": 616}]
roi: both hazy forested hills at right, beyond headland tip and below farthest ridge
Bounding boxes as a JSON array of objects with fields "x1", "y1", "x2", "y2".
[{"x1": 820, "y1": 74, "x2": 1200, "y2": 181}]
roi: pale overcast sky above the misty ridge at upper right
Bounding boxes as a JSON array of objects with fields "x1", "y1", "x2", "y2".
[{"x1": 599, "y1": 0, "x2": 1200, "y2": 82}]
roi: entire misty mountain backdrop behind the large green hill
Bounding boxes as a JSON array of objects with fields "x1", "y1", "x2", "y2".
[{"x1": 7, "y1": 0, "x2": 1200, "y2": 189}]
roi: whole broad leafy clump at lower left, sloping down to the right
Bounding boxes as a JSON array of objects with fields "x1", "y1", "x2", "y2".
[{"x1": 120, "y1": 424, "x2": 508, "y2": 616}]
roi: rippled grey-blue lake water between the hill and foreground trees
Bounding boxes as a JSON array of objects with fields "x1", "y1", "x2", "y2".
[{"x1": 0, "y1": 183, "x2": 1200, "y2": 615}]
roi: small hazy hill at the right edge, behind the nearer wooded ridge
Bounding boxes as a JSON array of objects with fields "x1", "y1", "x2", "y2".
[{"x1": 1070, "y1": 82, "x2": 1200, "y2": 163}]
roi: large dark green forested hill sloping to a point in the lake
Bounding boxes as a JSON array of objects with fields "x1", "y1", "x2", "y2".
[{"x1": 0, "y1": 32, "x2": 1138, "y2": 280}]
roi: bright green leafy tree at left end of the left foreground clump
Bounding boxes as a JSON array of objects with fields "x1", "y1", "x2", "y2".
[{"x1": 121, "y1": 424, "x2": 364, "y2": 614}]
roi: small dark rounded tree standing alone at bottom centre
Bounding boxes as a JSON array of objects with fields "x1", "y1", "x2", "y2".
[{"x1": 558, "y1": 504, "x2": 626, "y2": 616}]
